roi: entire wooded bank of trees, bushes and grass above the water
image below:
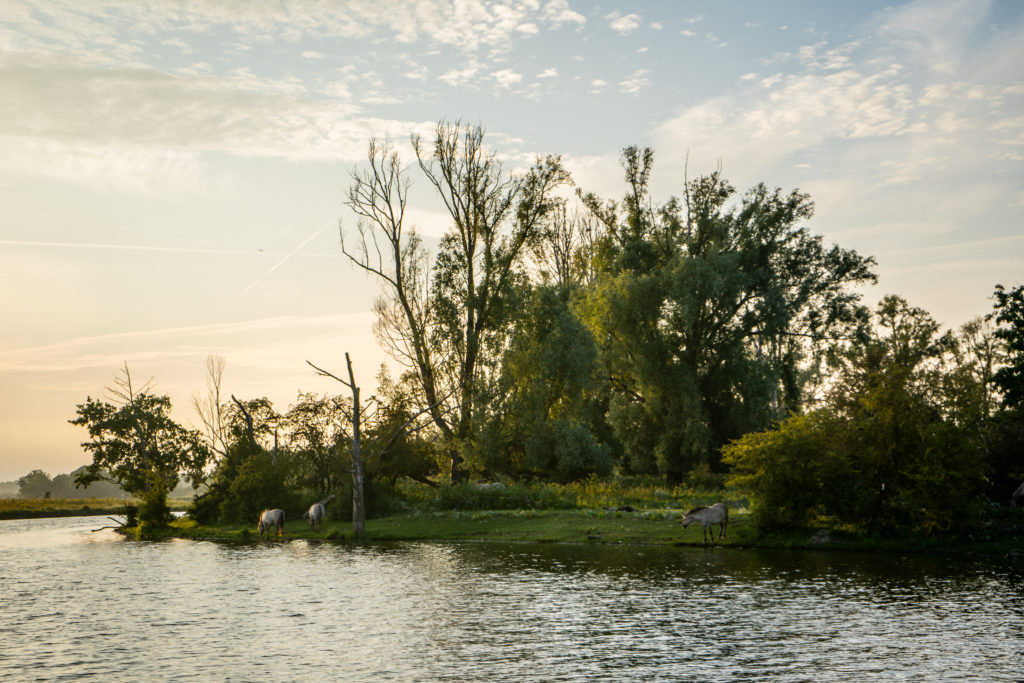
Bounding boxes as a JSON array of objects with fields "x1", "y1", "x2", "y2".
[{"x1": 37, "y1": 121, "x2": 1024, "y2": 552}]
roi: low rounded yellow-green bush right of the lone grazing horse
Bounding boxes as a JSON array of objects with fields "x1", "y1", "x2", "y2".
[{"x1": 722, "y1": 405, "x2": 984, "y2": 533}]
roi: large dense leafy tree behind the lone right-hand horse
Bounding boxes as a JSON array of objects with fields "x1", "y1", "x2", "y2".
[{"x1": 583, "y1": 147, "x2": 874, "y2": 481}]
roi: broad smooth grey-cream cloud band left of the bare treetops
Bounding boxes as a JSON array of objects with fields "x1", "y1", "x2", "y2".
[{"x1": 0, "y1": 52, "x2": 436, "y2": 191}]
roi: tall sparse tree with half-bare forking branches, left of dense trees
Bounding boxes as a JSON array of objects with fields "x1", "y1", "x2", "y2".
[{"x1": 342, "y1": 122, "x2": 567, "y2": 481}]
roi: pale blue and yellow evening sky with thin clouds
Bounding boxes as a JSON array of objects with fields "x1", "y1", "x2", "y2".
[{"x1": 0, "y1": 0, "x2": 1024, "y2": 480}]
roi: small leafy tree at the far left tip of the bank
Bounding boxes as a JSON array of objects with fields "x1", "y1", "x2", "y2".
[{"x1": 69, "y1": 365, "x2": 210, "y2": 525}]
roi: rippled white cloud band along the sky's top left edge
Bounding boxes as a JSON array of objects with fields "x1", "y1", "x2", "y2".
[{"x1": 0, "y1": 0, "x2": 586, "y2": 65}]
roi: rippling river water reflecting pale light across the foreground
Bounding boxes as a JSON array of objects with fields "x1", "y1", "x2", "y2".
[{"x1": 0, "y1": 517, "x2": 1024, "y2": 681}]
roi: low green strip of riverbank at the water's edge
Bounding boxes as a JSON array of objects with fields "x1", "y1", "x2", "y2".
[{"x1": 146, "y1": 509, "x2": 1024, "y2": 556}]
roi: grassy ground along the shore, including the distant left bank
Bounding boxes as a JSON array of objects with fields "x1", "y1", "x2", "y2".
[{"x1": 12, "y1": 477, "x2": 1024, "y2": 555}]
